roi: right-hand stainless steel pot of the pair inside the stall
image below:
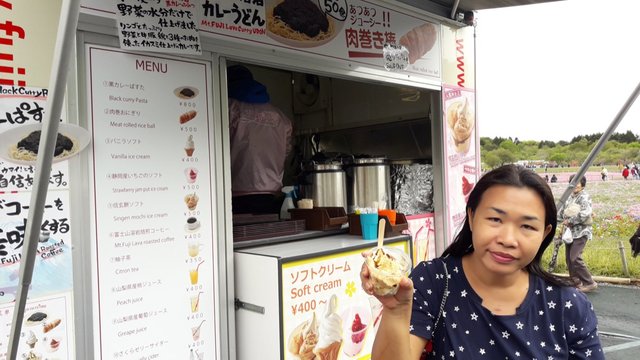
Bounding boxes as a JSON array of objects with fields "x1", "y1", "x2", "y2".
[{"x1": 348, "y1": 158, "x2": 392, "y2": 212}]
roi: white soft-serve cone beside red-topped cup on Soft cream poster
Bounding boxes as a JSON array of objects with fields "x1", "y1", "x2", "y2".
[{"x1": 313, "y1": 295, "x2": 342, "y2": 360}]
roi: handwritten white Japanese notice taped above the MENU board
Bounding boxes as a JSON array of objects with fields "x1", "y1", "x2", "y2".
[{"x1": 116, "y1": 0, "x2": 202, "y2": 54}]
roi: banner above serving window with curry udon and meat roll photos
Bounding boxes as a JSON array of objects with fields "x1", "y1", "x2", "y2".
[{"x1": 82, "y1": 0, "x2": 442, "y2": 81}]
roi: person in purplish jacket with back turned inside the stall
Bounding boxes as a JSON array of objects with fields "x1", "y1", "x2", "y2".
[{"x1": 227, "y1": 65, "x2": 293, "y2": 214}]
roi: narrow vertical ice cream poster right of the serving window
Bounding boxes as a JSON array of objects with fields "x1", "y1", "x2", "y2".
[{"x1": 442, "y1": 86, "x2": 478, "y2": 243}]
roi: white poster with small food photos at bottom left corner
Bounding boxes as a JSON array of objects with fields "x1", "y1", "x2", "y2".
[{"x1": 0, "y1": 294, "x2": 75, "y2": 360}]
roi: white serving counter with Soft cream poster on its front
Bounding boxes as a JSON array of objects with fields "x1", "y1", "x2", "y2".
[{"x1": 234, "y1": 234, "x2": 412, "y2": 359}]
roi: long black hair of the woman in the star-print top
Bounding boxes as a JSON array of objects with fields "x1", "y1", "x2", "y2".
[{"x1": 442, "y1": 165, "x2": 571, "y2": 286}]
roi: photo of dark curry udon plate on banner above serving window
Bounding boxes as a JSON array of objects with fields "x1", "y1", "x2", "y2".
[{"x1": 267, "y1": 0, "x2": 338, "y2": 46}]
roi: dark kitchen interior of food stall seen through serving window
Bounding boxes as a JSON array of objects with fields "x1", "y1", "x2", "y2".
[{"x1": 227, "y1": 60, "x2": 440, "y2": 242}]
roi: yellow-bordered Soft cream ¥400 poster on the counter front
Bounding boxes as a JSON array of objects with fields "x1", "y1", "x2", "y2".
[{"x1": 281, "y1": 241, "x2": 410, "y2": 360}]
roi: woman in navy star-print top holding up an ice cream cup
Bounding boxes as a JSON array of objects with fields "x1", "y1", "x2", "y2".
[{"x1": 361, "y1": 165, "x2": 604, "y2": 360}]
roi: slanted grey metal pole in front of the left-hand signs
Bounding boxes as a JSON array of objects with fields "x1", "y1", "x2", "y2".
[{"x1": 7, "y1": 0, "x2": 80, "y2": 360}]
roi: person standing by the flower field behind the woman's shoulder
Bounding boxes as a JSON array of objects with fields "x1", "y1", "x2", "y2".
[{"x1": 559, "y1": 175, "x2": 598, "y2": 292}]
